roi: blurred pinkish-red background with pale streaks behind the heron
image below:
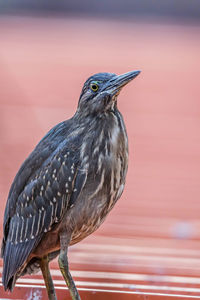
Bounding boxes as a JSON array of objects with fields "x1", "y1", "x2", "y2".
[{"x1": 0, "y1": 0, "x2": 200, "y2": 300}]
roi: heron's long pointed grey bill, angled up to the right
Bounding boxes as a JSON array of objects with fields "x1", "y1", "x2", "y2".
[{"x1": 106, "y1": 71, "x2": 140, "y2": 96}]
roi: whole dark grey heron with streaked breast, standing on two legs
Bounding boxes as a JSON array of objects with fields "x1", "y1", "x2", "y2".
[{"x1": 1, "y1": 70, "x2": 140, "y2": 300}]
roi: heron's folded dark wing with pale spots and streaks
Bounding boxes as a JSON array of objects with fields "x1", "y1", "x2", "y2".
[{"x1": 2, "y1": 120, "x2": 87, "y2": 289}]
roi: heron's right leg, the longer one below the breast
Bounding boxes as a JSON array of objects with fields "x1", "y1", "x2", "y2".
[{"x1": 58, "y1": 234, "x2": 81, "y2": 300}]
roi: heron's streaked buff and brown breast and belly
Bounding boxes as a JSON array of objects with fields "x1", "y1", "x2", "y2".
[{"x1": 67, "y1": 113, "x2": 128, "y2": 244}]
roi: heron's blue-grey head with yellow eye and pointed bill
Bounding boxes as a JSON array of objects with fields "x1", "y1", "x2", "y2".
[{"x1": 77, "y1": 71, "x2": 140, "y2": 115}]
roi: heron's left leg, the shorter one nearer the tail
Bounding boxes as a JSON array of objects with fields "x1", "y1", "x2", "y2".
[{"x1": 40, "y1": 255, "x2": 57, "y2": 300}]
